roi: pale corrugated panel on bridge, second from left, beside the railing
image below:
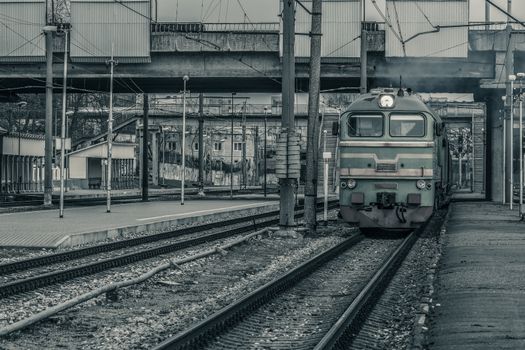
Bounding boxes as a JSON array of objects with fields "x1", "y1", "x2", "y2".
[{"x1": 70, "y1": 0, "x2": 150, "y2": 62}]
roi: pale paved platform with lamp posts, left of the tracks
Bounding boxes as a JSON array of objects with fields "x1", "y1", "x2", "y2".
[{"x1": 0, "y1": 199, "x2": 279, "y2": 248}]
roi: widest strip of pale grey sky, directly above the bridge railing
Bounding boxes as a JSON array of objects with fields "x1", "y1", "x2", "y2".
[{"x1": 151, "y1": 0, "x2": 279, "y2": 23}]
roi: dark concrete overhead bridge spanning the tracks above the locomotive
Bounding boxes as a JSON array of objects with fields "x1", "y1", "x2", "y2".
[{"x1": 0, "y1": 24, "x2": 525, "y2": 93}]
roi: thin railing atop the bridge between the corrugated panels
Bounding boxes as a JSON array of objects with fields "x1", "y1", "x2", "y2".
[{"x1": 151, "y1": 22, "x2": 279, "y2": 34}]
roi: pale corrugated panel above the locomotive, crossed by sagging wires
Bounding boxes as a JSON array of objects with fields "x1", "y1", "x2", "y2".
[{"x1": 385, "y1": 0, "x2": 469, "y2": 57}]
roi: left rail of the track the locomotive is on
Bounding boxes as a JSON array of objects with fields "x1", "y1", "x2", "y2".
[{"x1": 154, "y1": 235, "x2": 363, "y2": 350}]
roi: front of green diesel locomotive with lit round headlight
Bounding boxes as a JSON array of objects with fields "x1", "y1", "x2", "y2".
[{"x1": 339, "y1": 91, "x2": 441, "y2": 229}]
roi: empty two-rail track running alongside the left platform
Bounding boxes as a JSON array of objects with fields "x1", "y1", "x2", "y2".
[{"x1": 0, "y1": 201, "x2": 337, "y2": 298}]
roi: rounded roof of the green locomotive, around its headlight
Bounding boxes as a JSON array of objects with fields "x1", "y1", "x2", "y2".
[{"x1": 347, "y1": 93, "x2": 441, "y2": 122}]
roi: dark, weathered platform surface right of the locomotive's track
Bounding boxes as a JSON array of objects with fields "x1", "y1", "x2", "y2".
[{"x1": 428, "y1": 202, "x2": 525, "y2": 350}]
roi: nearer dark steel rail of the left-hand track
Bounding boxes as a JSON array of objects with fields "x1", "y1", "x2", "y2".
[{"x1": 0, "y1": 204, "x2": 340, "y2": 298}]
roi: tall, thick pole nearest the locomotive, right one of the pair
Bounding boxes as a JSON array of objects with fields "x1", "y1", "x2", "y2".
[{"x1": 304, "y1": 0, "x2": 322, "y2": 232}]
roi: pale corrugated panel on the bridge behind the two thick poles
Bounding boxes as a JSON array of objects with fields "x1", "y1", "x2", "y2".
[{"x1": 281, "y1": 0, "x2": 361, "y2": 58}]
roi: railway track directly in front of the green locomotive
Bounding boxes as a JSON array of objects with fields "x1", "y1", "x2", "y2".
[{"x1": 151, "y1": 230, "x2": 419, "y2": 350}]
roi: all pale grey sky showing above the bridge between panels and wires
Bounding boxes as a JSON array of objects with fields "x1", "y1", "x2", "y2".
[{"x1": 153, "y1": 0, "x2": 525, "y2": 23}]
